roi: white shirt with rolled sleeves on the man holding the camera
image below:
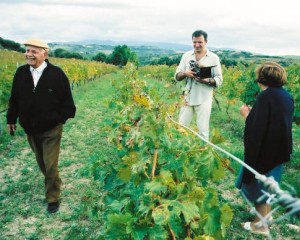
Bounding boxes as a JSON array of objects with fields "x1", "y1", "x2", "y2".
[{"x1": 175, "y1": 49, "x2": 223, "y2": 106}]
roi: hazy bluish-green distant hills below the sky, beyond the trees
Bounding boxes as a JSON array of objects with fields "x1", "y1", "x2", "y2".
[{"x1": 48, "y1": 40, "x2": 300, "y2": 66}]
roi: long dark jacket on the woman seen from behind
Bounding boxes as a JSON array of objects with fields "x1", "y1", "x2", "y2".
[{"x1": 242, "y1": 87, "x2": 294, "y2": 183}]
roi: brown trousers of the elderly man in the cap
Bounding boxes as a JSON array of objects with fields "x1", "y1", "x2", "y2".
[{"x1": 27, "y1": 124, "x2": 63, "y2": 203}]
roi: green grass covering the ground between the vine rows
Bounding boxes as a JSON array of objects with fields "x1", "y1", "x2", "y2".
[{"x1": 0, "y1": 70, "x2": 300, "y2": 240}]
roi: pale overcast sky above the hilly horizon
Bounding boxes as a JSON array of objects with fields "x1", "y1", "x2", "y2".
[{"x1": 0, "y1": 0, "x2": 300, "y2": 56}]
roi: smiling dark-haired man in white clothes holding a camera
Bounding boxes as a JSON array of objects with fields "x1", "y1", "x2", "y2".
[{"x1": 175, "y1": 30, "x2": 223, "y2": 140}]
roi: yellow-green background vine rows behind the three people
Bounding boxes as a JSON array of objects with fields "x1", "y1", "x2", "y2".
[{"x1": 0, "y1": 49, "x2": 300, "y2": 124}]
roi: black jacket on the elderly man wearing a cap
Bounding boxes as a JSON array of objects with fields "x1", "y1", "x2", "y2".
[{"x1": 7, "y1": 60, "x2": 76, "y2": 134}]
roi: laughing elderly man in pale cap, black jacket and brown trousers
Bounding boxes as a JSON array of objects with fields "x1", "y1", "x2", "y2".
[{"x1": 7, "y1": 39, "x2": 76, "y2": 213}]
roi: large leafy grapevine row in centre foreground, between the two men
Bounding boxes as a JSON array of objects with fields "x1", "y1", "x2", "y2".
[{"x1": 100, "y1": 64, "x2": 232, "y2": 239}]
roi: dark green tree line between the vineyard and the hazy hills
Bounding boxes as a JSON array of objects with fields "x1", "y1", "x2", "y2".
[{"x1": 0, "y1": 37, "x2": 294, "y2": 67}]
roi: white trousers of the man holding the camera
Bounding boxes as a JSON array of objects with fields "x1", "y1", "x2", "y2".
[{"x1": 179, "y1": 101, "x2": 212, "y2": 140}]
